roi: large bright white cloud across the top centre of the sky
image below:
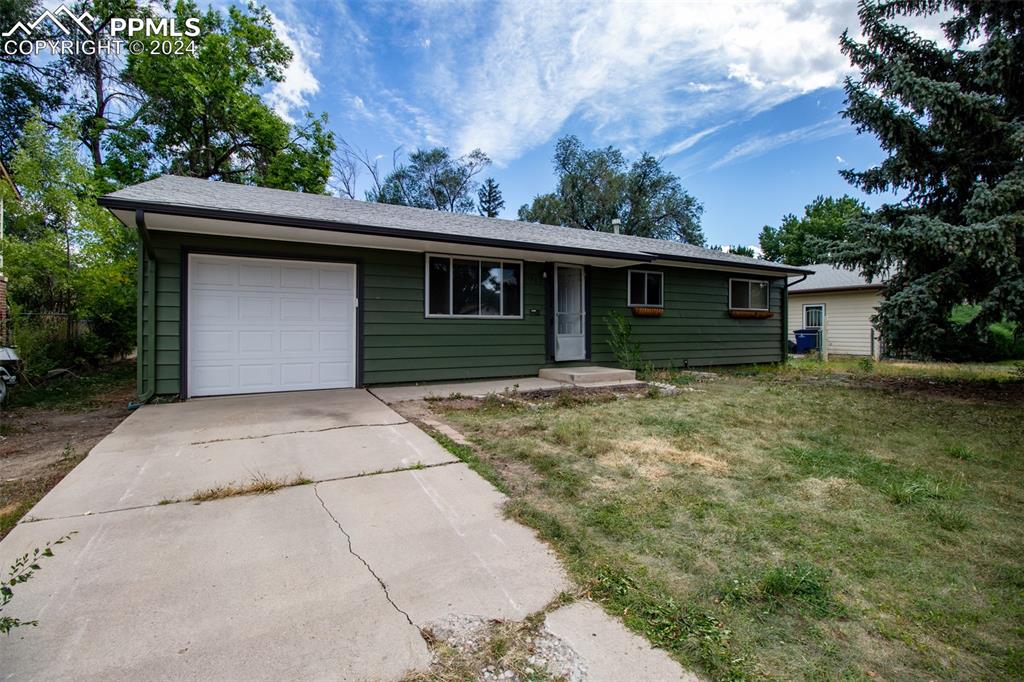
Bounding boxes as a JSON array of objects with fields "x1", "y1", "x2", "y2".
[{"x1": 436, "y1": 0, "x2": 857, "y2": 162}]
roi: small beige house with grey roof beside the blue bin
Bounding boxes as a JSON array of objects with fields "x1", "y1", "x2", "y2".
[{"x1": 787, "y1": 264, "x2": 883, "y2": 356}]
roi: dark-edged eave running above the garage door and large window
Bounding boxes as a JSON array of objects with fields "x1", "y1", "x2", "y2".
[{"x1": 96, "y1": 195, "x2": 657, "y2": 262}]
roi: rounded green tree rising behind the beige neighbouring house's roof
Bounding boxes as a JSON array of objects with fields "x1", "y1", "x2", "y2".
[{"x1": 759, "y1": 195, "x2": 867, "y2": 265}]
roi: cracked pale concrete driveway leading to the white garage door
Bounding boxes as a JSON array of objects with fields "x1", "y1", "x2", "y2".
[{"x1": 0, "y1": 390, "x2": 567, "y2": 680}]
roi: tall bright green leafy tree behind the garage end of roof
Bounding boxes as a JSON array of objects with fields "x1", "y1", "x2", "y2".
[{"x1": 123, "y1": 0, "x2": 335, "y2": 193}]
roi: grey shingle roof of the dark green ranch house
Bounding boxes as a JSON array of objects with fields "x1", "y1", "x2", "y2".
[{"x1": 99, "y1": 175, "x2": 802, "y2": 274}]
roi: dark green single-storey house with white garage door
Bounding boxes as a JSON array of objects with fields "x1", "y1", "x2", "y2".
[{"x1": 99, "y1": 176, "x2": 807, "y2": 397}]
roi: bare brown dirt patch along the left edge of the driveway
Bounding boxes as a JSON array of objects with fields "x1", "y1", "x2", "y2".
[{"x1": 0, "y1": 400, "x2": 131, "y2": 482}]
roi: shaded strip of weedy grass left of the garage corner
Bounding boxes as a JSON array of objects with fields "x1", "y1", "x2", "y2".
[{"x1": 5, "y1": 361, "x2": 135, "y2": 412}]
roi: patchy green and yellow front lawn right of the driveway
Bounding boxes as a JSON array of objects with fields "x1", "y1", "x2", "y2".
[{"x1": 435, "y1": 374, "x2": 1024, "y2": 679}]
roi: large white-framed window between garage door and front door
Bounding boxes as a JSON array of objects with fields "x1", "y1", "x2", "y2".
[{"x1": 426, "y1": 255, "x2": 522, "y2": 317}]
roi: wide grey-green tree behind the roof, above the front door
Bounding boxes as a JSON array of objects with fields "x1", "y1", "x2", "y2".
[{"x1": 519, "y1": 135, "x2": 705, "y2": 246}]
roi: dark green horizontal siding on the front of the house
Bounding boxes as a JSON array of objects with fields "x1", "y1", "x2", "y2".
[{"x1": 140, "y1": 231, "x2": 781, "y2": 394}]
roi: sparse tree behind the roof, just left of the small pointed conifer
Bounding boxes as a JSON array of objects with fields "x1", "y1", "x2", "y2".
[{"x1": 367, "y1": 146, "x2": 490, "y2": 213}]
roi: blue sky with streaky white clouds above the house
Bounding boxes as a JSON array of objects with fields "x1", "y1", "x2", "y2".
[{"x1": 258, "y1": 0, "x2": 905, "y2": 245}]
